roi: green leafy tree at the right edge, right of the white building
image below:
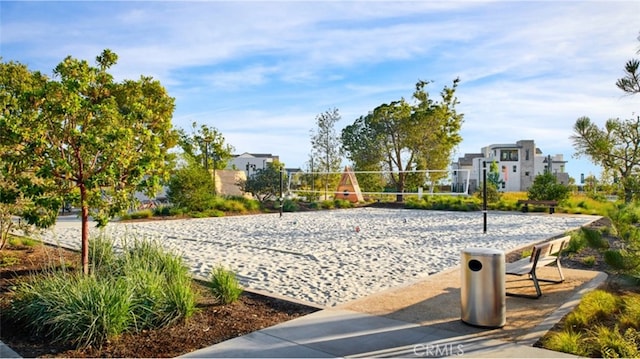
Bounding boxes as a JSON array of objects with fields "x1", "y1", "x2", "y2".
[{"x1": 571, "y1": 116, "x2": 640, "y2": 203}]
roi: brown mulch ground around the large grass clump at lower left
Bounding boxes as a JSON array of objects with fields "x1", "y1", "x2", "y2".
[{"x1": 0, "y1": 245, "x2": 317, "y2": 358}]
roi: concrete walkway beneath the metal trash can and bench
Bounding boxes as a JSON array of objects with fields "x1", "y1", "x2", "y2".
[{"x1": 183, "y1": 268, "x2": 607, "y2": 358}]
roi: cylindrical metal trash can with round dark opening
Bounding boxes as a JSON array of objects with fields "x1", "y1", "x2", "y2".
[{"x1": 460, "y1": 248, "x2": 507, "y2": 328}]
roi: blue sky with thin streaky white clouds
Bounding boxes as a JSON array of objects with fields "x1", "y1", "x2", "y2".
[{"x1": 0, "y1": 1, "x2": 640, "y2": 180}]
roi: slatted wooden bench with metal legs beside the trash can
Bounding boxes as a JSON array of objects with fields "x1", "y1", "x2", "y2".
[{"x1": 506, "y1": 236, "x2": 571, "y2": 299}]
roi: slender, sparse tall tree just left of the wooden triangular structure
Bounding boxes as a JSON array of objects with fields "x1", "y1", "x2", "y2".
[{"x1": 311, "y1": 108, "x2": 342, "y2": 199}]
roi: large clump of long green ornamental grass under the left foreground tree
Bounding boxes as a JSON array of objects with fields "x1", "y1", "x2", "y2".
[{"x1": 8, "y1": 238, "x2": 196, "y2": 348}]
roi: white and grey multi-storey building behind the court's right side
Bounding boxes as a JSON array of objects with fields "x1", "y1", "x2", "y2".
[{"x1": 452, "y1": 140, "x2": 569, "y2": 193}]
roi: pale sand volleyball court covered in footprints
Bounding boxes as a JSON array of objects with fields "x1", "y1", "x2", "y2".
[{"x1": 42, "y1": 208, "x2": 597, "y2": 308}]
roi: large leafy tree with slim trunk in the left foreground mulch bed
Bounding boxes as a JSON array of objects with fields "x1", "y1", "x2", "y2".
[{"x1": 0, "y1": 50, "x2": 177, "y2": 273}]
